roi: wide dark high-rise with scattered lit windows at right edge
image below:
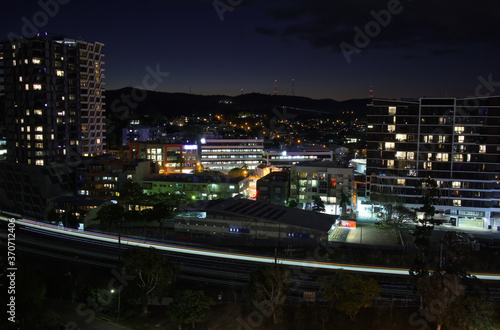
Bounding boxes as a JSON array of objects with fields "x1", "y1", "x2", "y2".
[{"x1": 366, "y1": 96, "x2": 500, "y2": 229}]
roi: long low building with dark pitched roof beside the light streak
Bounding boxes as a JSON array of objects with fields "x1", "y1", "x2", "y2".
[{"x1": 174, "y1": 199, "x2": 337, "y2": 247}]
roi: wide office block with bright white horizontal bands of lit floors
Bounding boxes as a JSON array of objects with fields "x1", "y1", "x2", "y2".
[{"x1": 200, "y1": 139, "x2": 264, "y2": 173}]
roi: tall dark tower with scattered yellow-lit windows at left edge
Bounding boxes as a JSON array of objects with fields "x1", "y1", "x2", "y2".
[{"x1": 0, "y1": 33, "x2": 105, "y2": 165}]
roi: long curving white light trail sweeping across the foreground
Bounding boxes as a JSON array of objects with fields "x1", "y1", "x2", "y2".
[{"x1": 0, "y1": 215, "x2": 500, "y2": 281}]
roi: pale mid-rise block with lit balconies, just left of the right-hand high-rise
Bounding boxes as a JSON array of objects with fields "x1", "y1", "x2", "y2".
[{"x1": 290, "y1": 161, "x2": 355, "y2": 215}]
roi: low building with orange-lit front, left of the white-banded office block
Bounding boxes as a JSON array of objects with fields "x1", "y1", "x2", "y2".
[{"x1": 129, "y1": 142, "x2": 200, "y2": 173}]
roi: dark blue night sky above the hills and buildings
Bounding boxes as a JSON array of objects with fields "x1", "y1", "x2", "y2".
[{"x1": 0, "y1": 0, "x2": 500, "y2": 100}]
